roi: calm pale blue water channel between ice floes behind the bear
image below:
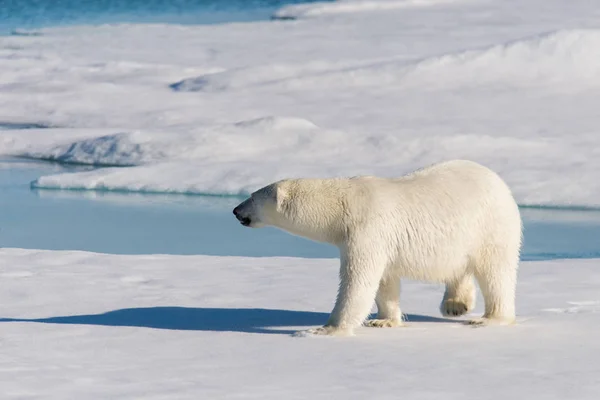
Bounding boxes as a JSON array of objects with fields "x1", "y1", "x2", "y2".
[{"x1": 0, "y1": 158, "x2": 600, "y2": 260}]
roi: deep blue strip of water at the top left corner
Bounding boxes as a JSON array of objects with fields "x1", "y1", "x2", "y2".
[{"x1": 0, "y1": 0, "x2": 326, "y2": 34}]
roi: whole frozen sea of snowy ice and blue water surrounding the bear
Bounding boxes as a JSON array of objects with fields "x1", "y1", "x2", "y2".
[{"x1": 0, "y1": 0, "x2": 600, "y2": 400}]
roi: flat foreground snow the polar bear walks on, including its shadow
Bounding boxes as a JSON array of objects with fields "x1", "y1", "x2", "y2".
[{"x1": 0, "y1": 249, "x2": 600, "y2": 400}]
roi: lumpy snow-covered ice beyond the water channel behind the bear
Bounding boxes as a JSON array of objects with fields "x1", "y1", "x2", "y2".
[{"x1": 0, "y1": 0, "x2": 600, "y2": 207}]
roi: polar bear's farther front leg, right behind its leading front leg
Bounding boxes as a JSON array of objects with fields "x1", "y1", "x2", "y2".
[{"x1": 365, "y1": 276, "x2": 402, "y2": 328}]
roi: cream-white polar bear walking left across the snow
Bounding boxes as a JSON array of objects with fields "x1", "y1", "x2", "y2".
[{"x1": 233, "y1": 160, "x2": 522, "y2": 335}]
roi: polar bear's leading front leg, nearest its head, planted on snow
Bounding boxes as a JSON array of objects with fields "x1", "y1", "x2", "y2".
[{"x1": 300, "y1": 247, "x2": 385, "y2": 336}]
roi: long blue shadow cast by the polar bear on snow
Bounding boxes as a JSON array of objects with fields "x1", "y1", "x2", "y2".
[{"x1": 0, "y1": 307, "x2": 456, "y2": 334}]
